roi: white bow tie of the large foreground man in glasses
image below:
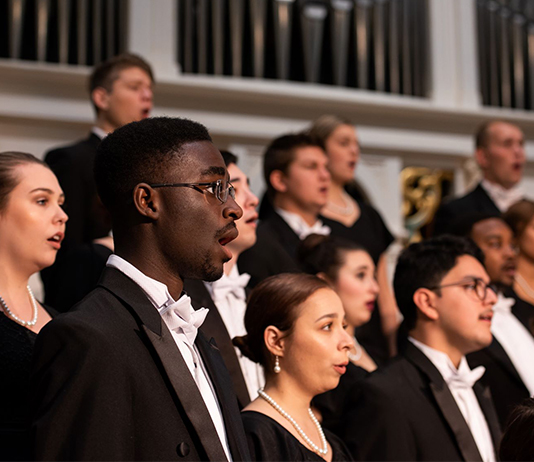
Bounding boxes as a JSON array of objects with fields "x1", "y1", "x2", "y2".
[{"x1": 161, "y1": 295, "x2": 209, "y2": 346}]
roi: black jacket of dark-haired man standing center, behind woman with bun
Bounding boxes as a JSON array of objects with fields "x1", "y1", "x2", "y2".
[{"x1": 239, "y1": 211, "x2": 300, "y2": 288}]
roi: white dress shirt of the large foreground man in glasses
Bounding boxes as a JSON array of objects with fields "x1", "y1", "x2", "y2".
[{"x1": 106, "y1": 254, "x2": 232, "y2": 461}]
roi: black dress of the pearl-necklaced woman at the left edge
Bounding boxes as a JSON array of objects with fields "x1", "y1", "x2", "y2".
[{"x1": 0, "y1": 307, "x2": 57, "y2": 460}]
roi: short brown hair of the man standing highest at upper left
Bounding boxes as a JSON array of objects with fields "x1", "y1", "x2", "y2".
[{"x1": 89, "y1": 53, "x2": 154, "y2": 112}]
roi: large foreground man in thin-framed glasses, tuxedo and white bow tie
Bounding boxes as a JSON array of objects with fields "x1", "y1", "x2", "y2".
[{"x1": 32, "y1": 117, "x2": 250, "y2": 461}]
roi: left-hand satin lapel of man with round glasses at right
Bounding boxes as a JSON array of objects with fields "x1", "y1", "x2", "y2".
[{"x1": 404, "y1": 342, "x2": 482, "y2": 462}]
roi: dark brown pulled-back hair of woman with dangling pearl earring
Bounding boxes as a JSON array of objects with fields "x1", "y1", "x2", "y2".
[{"x1": 233, "y1": 273, "x2": 332, "y2": 375}]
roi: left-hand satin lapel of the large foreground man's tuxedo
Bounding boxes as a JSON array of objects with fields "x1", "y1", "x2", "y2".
[{"x1": 100, "y1": 268, "x2": 230, "y2": 460}]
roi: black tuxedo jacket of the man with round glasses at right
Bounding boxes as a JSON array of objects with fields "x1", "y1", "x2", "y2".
[{"x1": 349, "y1": 343, "x2": 500, "y2": 461}]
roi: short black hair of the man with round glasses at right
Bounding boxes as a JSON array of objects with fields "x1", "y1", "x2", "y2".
[{"x1": 393, "y1": 235, "x2": 484, "y2": 333}]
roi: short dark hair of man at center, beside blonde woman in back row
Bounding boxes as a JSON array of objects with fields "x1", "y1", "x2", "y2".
[{"x1": 263, "y1": 133, "x2": 323, "y2": 200}]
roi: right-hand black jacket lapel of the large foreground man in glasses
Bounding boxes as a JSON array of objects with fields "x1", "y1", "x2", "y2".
[{"x1": 195, "y1": 331, "x2": 249, "y2": 461}]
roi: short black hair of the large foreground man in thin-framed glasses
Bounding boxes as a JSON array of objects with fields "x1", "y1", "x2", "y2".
[{"x1": 94, "y1": 117, "x2": 211, "y2": 215}]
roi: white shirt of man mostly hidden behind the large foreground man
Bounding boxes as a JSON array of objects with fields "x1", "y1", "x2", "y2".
[{"x1": 204, "y1": 265, "x2": 265, "y2": 401}]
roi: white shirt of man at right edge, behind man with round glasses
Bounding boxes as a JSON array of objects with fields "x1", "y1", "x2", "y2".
[{"x1": 491, "y1": 293, "x2": 534, "y2": 396}]
